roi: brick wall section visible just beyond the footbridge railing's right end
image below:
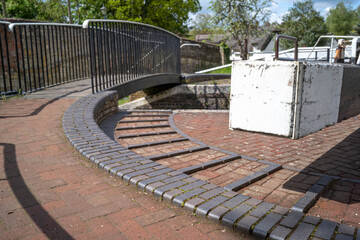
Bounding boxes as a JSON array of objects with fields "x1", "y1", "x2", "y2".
[{"x1": 181, "y1": 39, "x2": 225, "y2": 73}]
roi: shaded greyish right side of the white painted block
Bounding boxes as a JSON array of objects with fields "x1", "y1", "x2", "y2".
[{"x1": 295, "y1": 63, "x2": 344, "y2": 137}]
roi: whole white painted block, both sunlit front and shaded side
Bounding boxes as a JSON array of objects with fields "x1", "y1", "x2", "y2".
[{"x1": 230, "y1": 61, "x2": 343, "y2": 138}]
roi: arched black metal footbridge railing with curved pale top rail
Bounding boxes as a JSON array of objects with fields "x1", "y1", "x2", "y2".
[{"x1": 83, "y1": 20, "x2": 181, "y2": 92}]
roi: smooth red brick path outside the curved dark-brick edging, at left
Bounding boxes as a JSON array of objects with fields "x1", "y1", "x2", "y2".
[{"x1": 0, "y1": 98, "x2": 250, "y2": 239}]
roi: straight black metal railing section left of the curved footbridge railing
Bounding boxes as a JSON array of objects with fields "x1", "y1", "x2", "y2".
[{"x1": 1, "y1": 23, "x2": 90, "y2": 93}]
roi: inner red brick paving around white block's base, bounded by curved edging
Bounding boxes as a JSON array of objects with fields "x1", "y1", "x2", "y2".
[{"x1": 174, "y1": 112, "x2": 360, "y2": 176}]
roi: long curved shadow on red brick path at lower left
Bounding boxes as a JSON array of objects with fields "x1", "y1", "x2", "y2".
[{"x1": 0, "y1": 143, "x2": 73, "y2": 239}]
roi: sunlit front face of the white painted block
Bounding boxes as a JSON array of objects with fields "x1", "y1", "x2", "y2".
[{"x1": 230, "y1": 61, "x2": 296, "y2": 136}]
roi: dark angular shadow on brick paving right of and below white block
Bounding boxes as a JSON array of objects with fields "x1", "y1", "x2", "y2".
[{"x1": 283, "y1": 128, "x2": 360, "y2": 204}]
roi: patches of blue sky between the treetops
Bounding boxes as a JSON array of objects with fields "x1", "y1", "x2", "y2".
[{"x1": 194, "y1": 0, "x2": 360, "y2": 23}]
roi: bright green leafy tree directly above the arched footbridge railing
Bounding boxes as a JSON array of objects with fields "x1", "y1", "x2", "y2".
[{"x1": 105, "y1": 0, "x2": 201, "y2": 34}]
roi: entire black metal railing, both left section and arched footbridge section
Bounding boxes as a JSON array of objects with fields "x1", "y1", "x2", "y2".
[{"x1": 0, "y1": 20, "x2": 180, "y2": 95}]
